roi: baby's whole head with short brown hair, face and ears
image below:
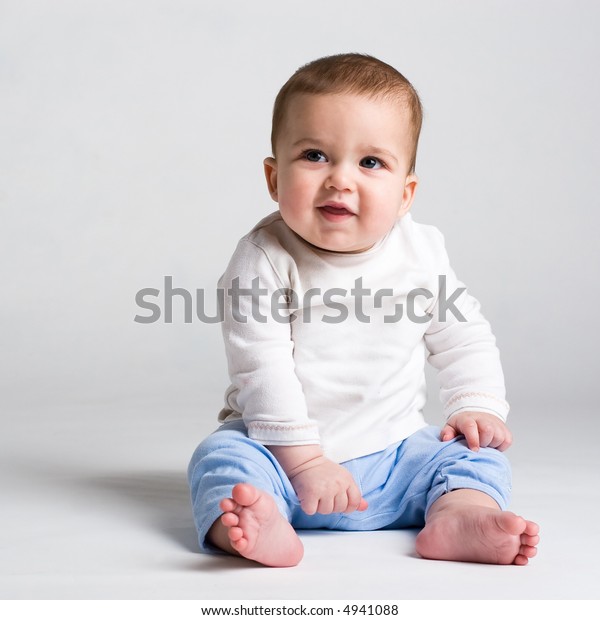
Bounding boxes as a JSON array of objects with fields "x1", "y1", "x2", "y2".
[{"x1": 264, "y1": 54, "x2": 422, "y2": 252}]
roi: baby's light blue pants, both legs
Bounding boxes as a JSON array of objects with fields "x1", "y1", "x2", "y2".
[{"x1": 188, "y1": 420, "x2": 511, "y2": 553}]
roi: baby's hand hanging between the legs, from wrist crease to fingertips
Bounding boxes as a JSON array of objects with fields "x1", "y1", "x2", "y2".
[{"x1": 290, "y1": 456, "x2": 368, "y2": 515}]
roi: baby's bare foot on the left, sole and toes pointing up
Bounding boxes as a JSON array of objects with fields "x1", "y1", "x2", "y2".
[{"x1": 211, "y1": 483, "x2": 304, "y2": 567}]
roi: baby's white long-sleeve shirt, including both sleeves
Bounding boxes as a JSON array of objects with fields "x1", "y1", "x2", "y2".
[{"x1": 219, "y1": 212, "x2": 508, "y2": 463}]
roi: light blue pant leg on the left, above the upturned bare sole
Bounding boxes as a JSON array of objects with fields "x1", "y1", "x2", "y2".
[{"x1": 188, "y1": 420, "x2": 298, "y2": 552}]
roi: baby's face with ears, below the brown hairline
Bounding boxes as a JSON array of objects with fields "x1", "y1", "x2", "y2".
[{"x1": 265, "y1": 94, "x2": 417, "y2": 252}]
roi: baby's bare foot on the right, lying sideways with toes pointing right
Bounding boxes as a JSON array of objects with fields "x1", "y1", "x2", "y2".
[{"x1": 416, "y1": 505, "x2": 540, "y2": 566}]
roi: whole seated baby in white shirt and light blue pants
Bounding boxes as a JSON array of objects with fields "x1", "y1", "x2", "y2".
[{"x1": 189, "y1": 54, "x2": 539, "y2": 567}]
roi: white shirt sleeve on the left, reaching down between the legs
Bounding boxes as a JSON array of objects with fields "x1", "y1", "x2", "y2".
[{"x1": 219, "y1": 239, "x2": 319, "y2": 446}]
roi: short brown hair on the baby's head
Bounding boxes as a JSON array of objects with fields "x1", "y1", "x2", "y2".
[{"x1": 271, "y1": 54, "x2": 423, "y2": 172}]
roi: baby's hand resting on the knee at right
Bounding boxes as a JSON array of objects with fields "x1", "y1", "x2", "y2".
[{"x1": 440, "y1": 411, "x2": 512, "y2": 452}]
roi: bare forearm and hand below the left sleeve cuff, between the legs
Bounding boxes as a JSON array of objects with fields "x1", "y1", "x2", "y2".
[{"x1": 269, "y1": 445, "x2": 367, "y2": 515}]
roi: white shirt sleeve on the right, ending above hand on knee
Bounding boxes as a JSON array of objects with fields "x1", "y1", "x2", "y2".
[{"x1": 425, "y1": 234, "x2": 509, "y2": 420}]
